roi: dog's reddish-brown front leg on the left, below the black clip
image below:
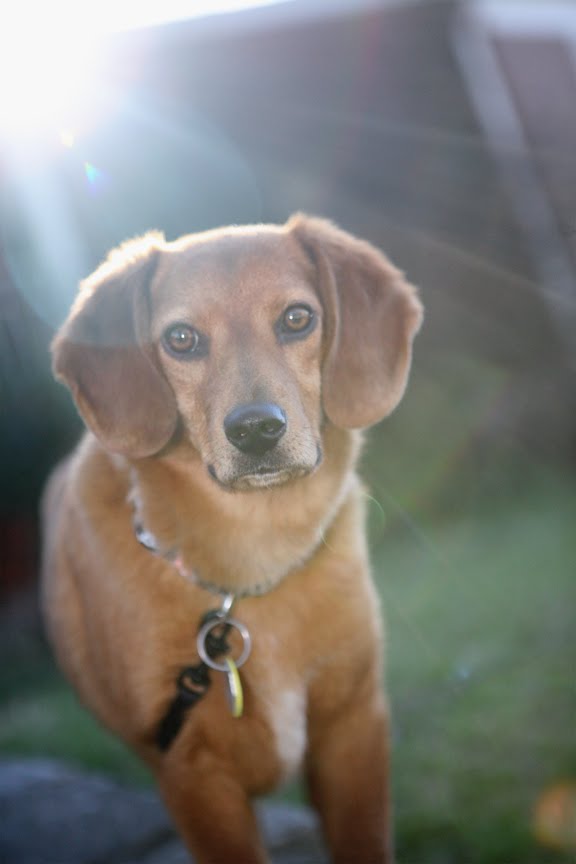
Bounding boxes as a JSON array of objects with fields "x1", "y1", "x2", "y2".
[{"x1": 158, "y1": 748, "x2": 268, "y2": 864}]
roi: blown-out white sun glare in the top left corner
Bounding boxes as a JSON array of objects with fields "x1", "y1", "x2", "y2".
[{"x1": 0, "y1": 0, "x2": 288, "y2": 138}]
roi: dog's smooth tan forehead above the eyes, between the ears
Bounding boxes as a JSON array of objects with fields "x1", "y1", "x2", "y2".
[{"x1": 154, "y1": 230, "x2": 312, "y2": 306}]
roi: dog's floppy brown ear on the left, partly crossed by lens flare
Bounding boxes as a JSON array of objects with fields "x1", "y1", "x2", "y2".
[{"x1": 52, "y1": 234, "x2": 177, "y2": 457}]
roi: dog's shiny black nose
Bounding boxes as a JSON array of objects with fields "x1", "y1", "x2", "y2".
[{"x1": 224, "y1": 402, "x2": 286, "y2": 456}]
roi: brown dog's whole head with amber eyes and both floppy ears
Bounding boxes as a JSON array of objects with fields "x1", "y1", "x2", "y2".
[{"x1": 53, "y1": 215, "x2": 422, "y2": 489}]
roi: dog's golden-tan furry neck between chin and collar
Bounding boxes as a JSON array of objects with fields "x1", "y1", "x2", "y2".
[{"x1": 126, "y1": 426, "x2": 361, "y2": 595}]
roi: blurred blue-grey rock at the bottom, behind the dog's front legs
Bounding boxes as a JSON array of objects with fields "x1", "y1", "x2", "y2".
[{"x1": 0, "y1": 759, "x2": 327, "y2": 864}]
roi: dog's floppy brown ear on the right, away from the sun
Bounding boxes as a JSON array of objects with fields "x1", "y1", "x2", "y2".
[{"x1": 286, "y1": 214, "x2": 422, "y2": 429}]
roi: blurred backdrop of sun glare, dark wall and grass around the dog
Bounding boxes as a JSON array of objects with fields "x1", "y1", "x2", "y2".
[{"x1": 0, "y1": 0, "x2": 576, "y2": 864}]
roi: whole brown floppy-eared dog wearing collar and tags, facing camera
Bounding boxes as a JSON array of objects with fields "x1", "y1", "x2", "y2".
[{"x1": 44, "y1": 215, "x2": 421, "y2": 864}]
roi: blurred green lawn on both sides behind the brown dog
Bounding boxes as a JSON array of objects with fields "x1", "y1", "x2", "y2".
[{"x1": 0, "y1": 462, "x2": 576, "y2": 864}]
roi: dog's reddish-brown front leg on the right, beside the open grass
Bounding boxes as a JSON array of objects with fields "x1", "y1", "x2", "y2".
[{"x1": 307, "y1": 680, "x2": 393, "y2": 864}]
